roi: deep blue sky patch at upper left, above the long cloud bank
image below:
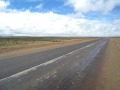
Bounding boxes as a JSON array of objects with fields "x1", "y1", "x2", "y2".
[{"x1": 9, "y1": 0, "x2": 74, "y2": 14}]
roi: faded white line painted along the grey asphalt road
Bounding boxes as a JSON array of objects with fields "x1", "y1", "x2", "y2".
[{"x1": 0, "y1": 41, "x2": 100, "y2": 82}]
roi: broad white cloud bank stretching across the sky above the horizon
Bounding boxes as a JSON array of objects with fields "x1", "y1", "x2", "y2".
[{"x1": 0, "y1": 11, "x2": 120, "y2": 36}]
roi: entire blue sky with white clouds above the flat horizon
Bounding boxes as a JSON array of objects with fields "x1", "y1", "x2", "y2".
[{"x1": 0, "y1": 0, "x2": 120, "y2": 37}]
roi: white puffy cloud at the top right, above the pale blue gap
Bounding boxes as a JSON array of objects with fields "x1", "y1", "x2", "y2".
[{"x1": 66, "y1": 0, "x2": 120, "y2": 14}]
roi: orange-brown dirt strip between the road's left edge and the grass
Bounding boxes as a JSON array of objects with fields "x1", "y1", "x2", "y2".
[{"x1": 0, "y1": 38, "x2": 98, "y2": 59}]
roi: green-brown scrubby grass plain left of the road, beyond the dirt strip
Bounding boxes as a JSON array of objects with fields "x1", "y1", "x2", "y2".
[{"x1": 0, "y1": 37, "x2": 70, "y2": 50}]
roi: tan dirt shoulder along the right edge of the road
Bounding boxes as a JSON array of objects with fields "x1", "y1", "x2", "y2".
[{"x1": 95, "y1": 39, "x2": 120, "y2": 90}]
